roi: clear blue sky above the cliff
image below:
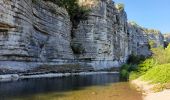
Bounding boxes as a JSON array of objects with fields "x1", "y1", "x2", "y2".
[{"x1": 113, "y1": 0, "x2": 170, "y2": 33}]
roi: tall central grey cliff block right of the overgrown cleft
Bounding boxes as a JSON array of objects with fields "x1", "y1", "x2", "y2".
[{"x1": 73, "y1": 0, "x2": 129, "y2": 68}]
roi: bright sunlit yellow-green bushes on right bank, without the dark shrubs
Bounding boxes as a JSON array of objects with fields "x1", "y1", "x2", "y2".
[{"x1": 127, "y1": 44, "x2": 170, "y2": 88}]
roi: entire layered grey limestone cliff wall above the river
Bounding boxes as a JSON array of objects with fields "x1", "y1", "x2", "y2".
[{"x1": 0, "y1": 0, "x2": 165, "y2": 71}]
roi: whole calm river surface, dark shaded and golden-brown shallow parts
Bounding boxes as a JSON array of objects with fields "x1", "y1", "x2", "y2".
[{"x1": 0, "y1": 74, "x2": 142, "y2": 100}]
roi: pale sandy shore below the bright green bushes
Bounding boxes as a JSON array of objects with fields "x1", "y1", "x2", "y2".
[{"x1": 131, "y1": 78, "x2": 170, "y2": 100}]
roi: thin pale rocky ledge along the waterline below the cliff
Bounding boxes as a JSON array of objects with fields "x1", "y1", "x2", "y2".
[{"x1": 0, "y1": 71, "x2": 119, "y2": 82}]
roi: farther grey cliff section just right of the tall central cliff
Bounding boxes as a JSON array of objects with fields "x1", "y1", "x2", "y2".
[{"x1": 128, "y1": 23, "x2": 151, "y2": 56}]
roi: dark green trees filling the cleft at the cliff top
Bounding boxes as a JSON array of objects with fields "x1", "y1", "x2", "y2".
[{"x1": 32, "y1": 0, "x2": 90, "y2": 36}]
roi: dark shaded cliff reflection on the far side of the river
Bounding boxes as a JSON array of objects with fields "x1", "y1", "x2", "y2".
[{"x1": 0, "y1": 74, "x2": 119, "y2": 100}]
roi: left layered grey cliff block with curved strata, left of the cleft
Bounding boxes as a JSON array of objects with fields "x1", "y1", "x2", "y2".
[{"x1": 0, "y1": 0, "x2": 74, "y2": 71}]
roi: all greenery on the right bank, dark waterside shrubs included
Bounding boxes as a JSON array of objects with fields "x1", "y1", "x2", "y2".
[{"x1": 120, "y1": 45, "x2": 170, "y2": 85}]
